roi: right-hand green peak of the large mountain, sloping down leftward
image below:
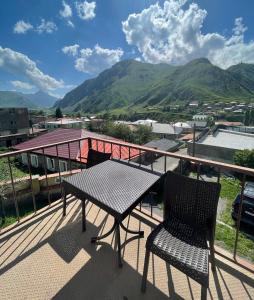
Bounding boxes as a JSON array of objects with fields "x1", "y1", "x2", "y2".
[{"x1": 135, "y1": 58, "x2": 254, "y2": 105}]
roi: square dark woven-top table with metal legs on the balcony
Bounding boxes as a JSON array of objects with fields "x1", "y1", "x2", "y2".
[{"x1": 63, "y1": 159, "x2": 162, "y2": 267}]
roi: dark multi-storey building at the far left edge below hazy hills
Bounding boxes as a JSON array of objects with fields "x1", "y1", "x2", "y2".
[{"x1": 0, "y1": 107, "x2": 29, "y2": 136}]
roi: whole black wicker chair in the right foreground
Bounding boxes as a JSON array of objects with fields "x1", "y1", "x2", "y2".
[{"x1": 141, "y1": 172, "x2": 220, "y2": 299}]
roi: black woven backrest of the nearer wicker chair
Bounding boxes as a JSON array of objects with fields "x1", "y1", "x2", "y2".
[{"x1": 164, "y1": 172, "x2": 221, "y2": 229}]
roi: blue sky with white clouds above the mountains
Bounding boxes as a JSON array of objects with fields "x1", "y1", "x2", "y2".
[{"x1": 0, "y1": 0, "x2": 254, "y2": 97}]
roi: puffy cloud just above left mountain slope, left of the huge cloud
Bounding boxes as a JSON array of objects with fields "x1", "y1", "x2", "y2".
[{"x1": 75, "y1": 45, "x2": 124, "y2": 74}]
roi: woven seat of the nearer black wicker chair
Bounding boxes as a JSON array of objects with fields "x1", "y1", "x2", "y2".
[{"x1": 146, "y1": 218, "x2": 209, "y2": 287}]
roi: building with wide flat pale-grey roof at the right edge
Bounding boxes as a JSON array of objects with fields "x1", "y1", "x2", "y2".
[{"x1": 188, "y1": 129, "x2": 254, "y2": 163}]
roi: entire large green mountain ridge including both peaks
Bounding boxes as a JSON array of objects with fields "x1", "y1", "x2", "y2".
[{"x1": 55, "y1": 58, "x2": 254, "y2": 113}]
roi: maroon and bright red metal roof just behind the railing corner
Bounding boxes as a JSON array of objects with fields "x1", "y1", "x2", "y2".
[{"x1": 14, "y1": 128, "x2": 139, "y2": 162}]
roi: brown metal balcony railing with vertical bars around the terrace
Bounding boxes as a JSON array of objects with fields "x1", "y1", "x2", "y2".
[{"x1": 0, "y1": 137, "x2": 254, "y2": 259}]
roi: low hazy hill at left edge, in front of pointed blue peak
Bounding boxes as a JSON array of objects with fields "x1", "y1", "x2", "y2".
[{"x1": 0, "y1": 91, "x2": 37, "y2": 108}]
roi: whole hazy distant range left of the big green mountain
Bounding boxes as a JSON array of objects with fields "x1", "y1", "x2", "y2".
[{"x1": 0, "y1": 91, "x2": 57, "y2": 109}]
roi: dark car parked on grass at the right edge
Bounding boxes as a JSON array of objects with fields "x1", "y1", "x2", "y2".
[{"x1": 232, "y1": 182, "x2": 254, "y2": 226}]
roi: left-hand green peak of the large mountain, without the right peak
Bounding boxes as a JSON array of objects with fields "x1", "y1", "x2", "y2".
[{"x1": 55, "y1": 60, "x2": 176, "y2": 112}]
